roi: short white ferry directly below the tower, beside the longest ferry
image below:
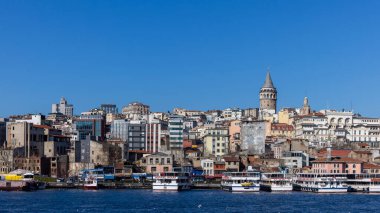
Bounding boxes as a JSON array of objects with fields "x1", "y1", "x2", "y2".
[{"x1": 260, "y1": 173, "x2": 293, "y2": 192}]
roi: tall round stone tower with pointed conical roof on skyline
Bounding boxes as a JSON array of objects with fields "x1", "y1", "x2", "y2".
[{"x1": 260, "y1": 70, "x2": 277, "y2": 113}]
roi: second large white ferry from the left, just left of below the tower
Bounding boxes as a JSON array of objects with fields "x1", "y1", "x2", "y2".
[{"x1": 222, "y1": 171, "x2": 261, "y2": 192}]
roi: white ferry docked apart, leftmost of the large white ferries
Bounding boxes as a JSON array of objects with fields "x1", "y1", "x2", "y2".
[{"x1": 153, "y1": 172, "x2": 191, "y2": 191}]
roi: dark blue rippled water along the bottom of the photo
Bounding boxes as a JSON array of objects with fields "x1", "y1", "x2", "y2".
[{"x1": 0, "y1": 190, "x2": 380, "y2": 212}]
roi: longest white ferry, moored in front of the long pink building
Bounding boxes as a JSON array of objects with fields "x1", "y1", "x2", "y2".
[{"x1": 293, "y1": 173, "x2": 348, "y2": 193}]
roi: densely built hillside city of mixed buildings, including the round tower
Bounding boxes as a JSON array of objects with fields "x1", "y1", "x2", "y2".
[{"x1": 0, "y1": 71, "x2": 380, "y2": 189}]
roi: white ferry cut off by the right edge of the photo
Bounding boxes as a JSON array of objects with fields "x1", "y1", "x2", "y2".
[{"x1": 347, "y1": 174, "x2": 380, "y2": 193}]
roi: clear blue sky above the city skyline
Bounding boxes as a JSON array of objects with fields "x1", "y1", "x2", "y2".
[{"x1": 0, "y1": 0, "x2": 380, "y2": 117}]
